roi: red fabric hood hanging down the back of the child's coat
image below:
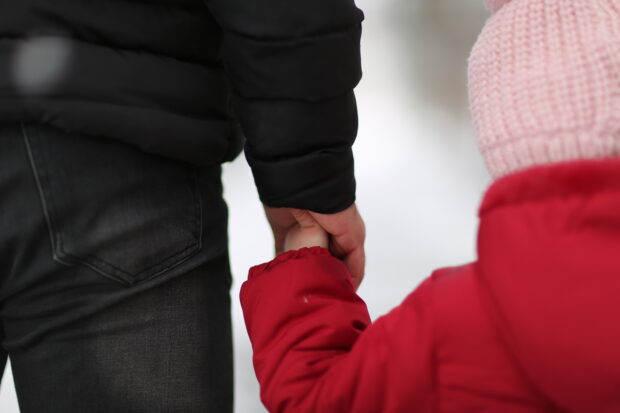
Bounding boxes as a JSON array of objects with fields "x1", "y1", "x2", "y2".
[{"x1": 478, "y1": 160, "x2": 620, "y2": 413}]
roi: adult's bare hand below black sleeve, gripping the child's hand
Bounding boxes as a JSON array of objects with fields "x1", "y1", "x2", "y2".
[{"x1": 265, "y1": 204, "x2": 366, "y2": 288}]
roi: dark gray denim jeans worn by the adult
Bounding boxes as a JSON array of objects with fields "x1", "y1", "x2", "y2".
[{"x1": 0, "y1": 125, "x2": 232, "y2": 413}]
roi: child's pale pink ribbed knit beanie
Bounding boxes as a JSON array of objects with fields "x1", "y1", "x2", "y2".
[{"x1": 469, "y1": 0, "x2": 620, "y2": 177}]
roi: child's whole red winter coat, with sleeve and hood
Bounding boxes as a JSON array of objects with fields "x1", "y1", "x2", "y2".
[{"x1": 241, "y1": 160, "x2": 620, "y2": 413}]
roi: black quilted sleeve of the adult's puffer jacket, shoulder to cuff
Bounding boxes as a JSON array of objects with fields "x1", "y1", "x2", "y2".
[{"x1": 205, "y1": 0, "x2": 363, "y2": 213}]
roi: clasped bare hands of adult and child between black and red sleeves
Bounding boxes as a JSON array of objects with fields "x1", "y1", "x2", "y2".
[{"x1": 265, "y1": 204, "x2": 366, "y2": 288}]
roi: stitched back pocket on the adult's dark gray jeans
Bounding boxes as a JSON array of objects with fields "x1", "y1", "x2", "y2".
[{"x1": 23, "y1": 125, "x2": 203, "y2": 284}]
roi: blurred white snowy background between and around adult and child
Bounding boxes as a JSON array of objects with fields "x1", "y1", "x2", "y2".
[{"x1": 0, "y1": 0, "x2": 490, "y2": 413}]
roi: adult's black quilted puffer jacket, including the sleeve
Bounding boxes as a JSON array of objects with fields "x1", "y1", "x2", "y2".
[{"x1": 0, "y1": 0, "x2": 363, "y2": 212}]
